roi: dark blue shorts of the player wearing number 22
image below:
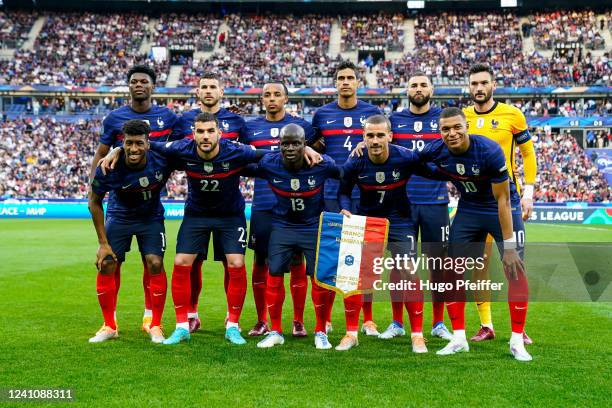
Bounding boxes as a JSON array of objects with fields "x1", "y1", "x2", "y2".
[{"x1": 176, "y1": 214, "x2": 247, "y2": 256}]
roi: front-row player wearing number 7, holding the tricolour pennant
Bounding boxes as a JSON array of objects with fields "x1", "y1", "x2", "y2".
[{"x1": 336, "y1": 115, "x2": 427, "y2": 353}]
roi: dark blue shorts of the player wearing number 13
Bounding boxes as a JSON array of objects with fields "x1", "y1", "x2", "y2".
[{"x1": 268, "y1": 225, "x2": 318, "y2": 276}]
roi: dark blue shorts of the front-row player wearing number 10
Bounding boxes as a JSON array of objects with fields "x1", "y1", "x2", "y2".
[{"x1": 449, "y1": 209, "x2": 525, "y2": 258}]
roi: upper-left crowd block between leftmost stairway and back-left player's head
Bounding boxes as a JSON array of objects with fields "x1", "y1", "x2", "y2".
[{"x1": 0, "y1": 13, "x2": 168, "y2": 86}]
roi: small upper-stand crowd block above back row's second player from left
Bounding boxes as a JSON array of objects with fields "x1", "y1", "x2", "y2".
[{"x1": 149, "y1": 13, "x2": 221, "y2": 51}]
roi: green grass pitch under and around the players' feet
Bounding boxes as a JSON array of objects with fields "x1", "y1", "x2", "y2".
[{"x1": 0, "y1": 220, "x2": 612, "y2": 407}]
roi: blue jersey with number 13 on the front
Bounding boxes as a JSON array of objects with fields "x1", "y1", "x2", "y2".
[{"x1": 255, "y1": 153, "x2": 340, "y2": 227}]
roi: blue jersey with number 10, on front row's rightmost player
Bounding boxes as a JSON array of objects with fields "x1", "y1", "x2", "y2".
[{"x1": 417, "y1": 135, "x2": 521, "y2": 214}]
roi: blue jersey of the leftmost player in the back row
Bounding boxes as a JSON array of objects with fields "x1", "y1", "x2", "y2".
[{"x1": 100, "y1": 106, "x2": 191, "y2": 147}]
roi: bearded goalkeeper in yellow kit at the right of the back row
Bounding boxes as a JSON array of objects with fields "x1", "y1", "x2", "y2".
[{"x1": 463, "y1": 64, "x2": 537, "y2": 344}]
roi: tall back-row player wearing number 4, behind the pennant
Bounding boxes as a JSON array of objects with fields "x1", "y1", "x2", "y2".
[{"x1": 312, "y1": 61, "x2": 382, "y2": 336}]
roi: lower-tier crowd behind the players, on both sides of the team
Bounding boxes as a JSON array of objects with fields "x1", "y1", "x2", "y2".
[{"x1": 0, "y1": 116, "x2": 612, "y2": 202}]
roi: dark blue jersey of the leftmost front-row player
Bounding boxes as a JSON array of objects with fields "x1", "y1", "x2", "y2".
[{"x1": 91, "y1": 151, "x2": 173, "y2": 222}]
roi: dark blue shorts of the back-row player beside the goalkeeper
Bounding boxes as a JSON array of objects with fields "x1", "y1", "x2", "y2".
[{"x1": 410, "y1": 204, "x2": 450, "y2": 256}]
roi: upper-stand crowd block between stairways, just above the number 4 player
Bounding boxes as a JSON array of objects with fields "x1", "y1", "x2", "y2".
[{"x1": 341, "y1": 13, "x2": 404, "y2": 51}]
